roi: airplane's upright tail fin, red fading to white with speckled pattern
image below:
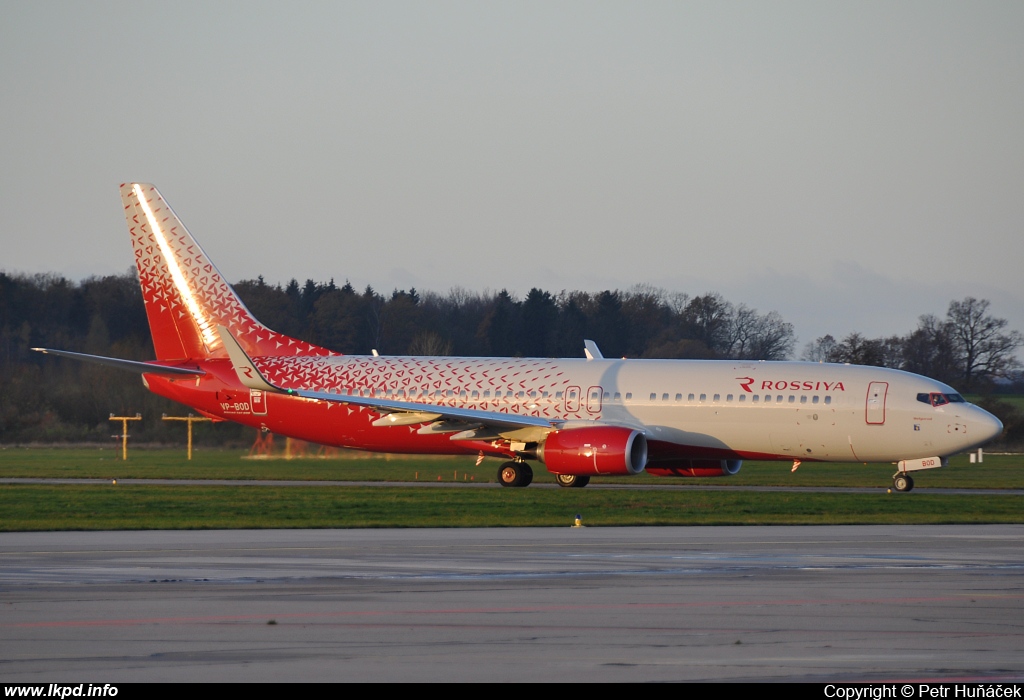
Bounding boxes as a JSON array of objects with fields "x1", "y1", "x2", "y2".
[{"x1": 121, "y1": 182, "x2": 334, "y2": 360}]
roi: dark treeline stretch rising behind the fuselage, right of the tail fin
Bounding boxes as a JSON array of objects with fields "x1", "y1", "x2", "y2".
[{"x1": 234, "y1": 277, "x2": 795, "y2": 359}]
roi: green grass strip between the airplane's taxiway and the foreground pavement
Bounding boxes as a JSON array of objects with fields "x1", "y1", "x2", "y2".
[{"x1": 0, "y1": 484, "x2": 1024, "y2": 531}]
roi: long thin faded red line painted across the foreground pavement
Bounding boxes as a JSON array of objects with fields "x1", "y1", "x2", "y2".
[{"x1": 9, "y1": 594, "x2": 1024, "y2": 628}]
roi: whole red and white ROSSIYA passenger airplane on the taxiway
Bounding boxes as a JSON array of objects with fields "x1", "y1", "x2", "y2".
[{"x1": 34, "y1": 182, "x2": 1002, "y2": 491}]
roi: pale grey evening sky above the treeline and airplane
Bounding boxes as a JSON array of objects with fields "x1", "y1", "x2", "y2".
[{"x1": 0, "y1": 0, "x2": 1024, "y2": 355}]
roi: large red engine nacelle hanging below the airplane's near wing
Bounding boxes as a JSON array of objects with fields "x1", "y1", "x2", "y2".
[{"x1": 537, "y1": 426, "x2": 647, "y2": 476}]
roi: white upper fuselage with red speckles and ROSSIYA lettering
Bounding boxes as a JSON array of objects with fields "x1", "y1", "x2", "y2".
[{"x1": 245, "y1": 356, "x2": 1001, "y2": 462}]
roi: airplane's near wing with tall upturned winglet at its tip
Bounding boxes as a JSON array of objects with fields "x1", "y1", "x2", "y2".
[{"x1": 217, "y1": 325, "x2": 565, "y2": 442}]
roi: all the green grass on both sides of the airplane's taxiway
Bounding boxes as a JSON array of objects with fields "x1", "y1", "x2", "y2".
[{"x1": 0, "y1": 447, "x2": 1024, "y2": 531}]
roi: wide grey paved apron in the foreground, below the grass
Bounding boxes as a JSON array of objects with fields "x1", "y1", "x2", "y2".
[{"x1": 0, "y1": 526, "x2": 1024, "y2": 683}]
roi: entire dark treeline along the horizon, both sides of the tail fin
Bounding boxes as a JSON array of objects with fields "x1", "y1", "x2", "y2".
[{"x1": 0, "y1": 272, "x2": 1021, "y2": 444}]
